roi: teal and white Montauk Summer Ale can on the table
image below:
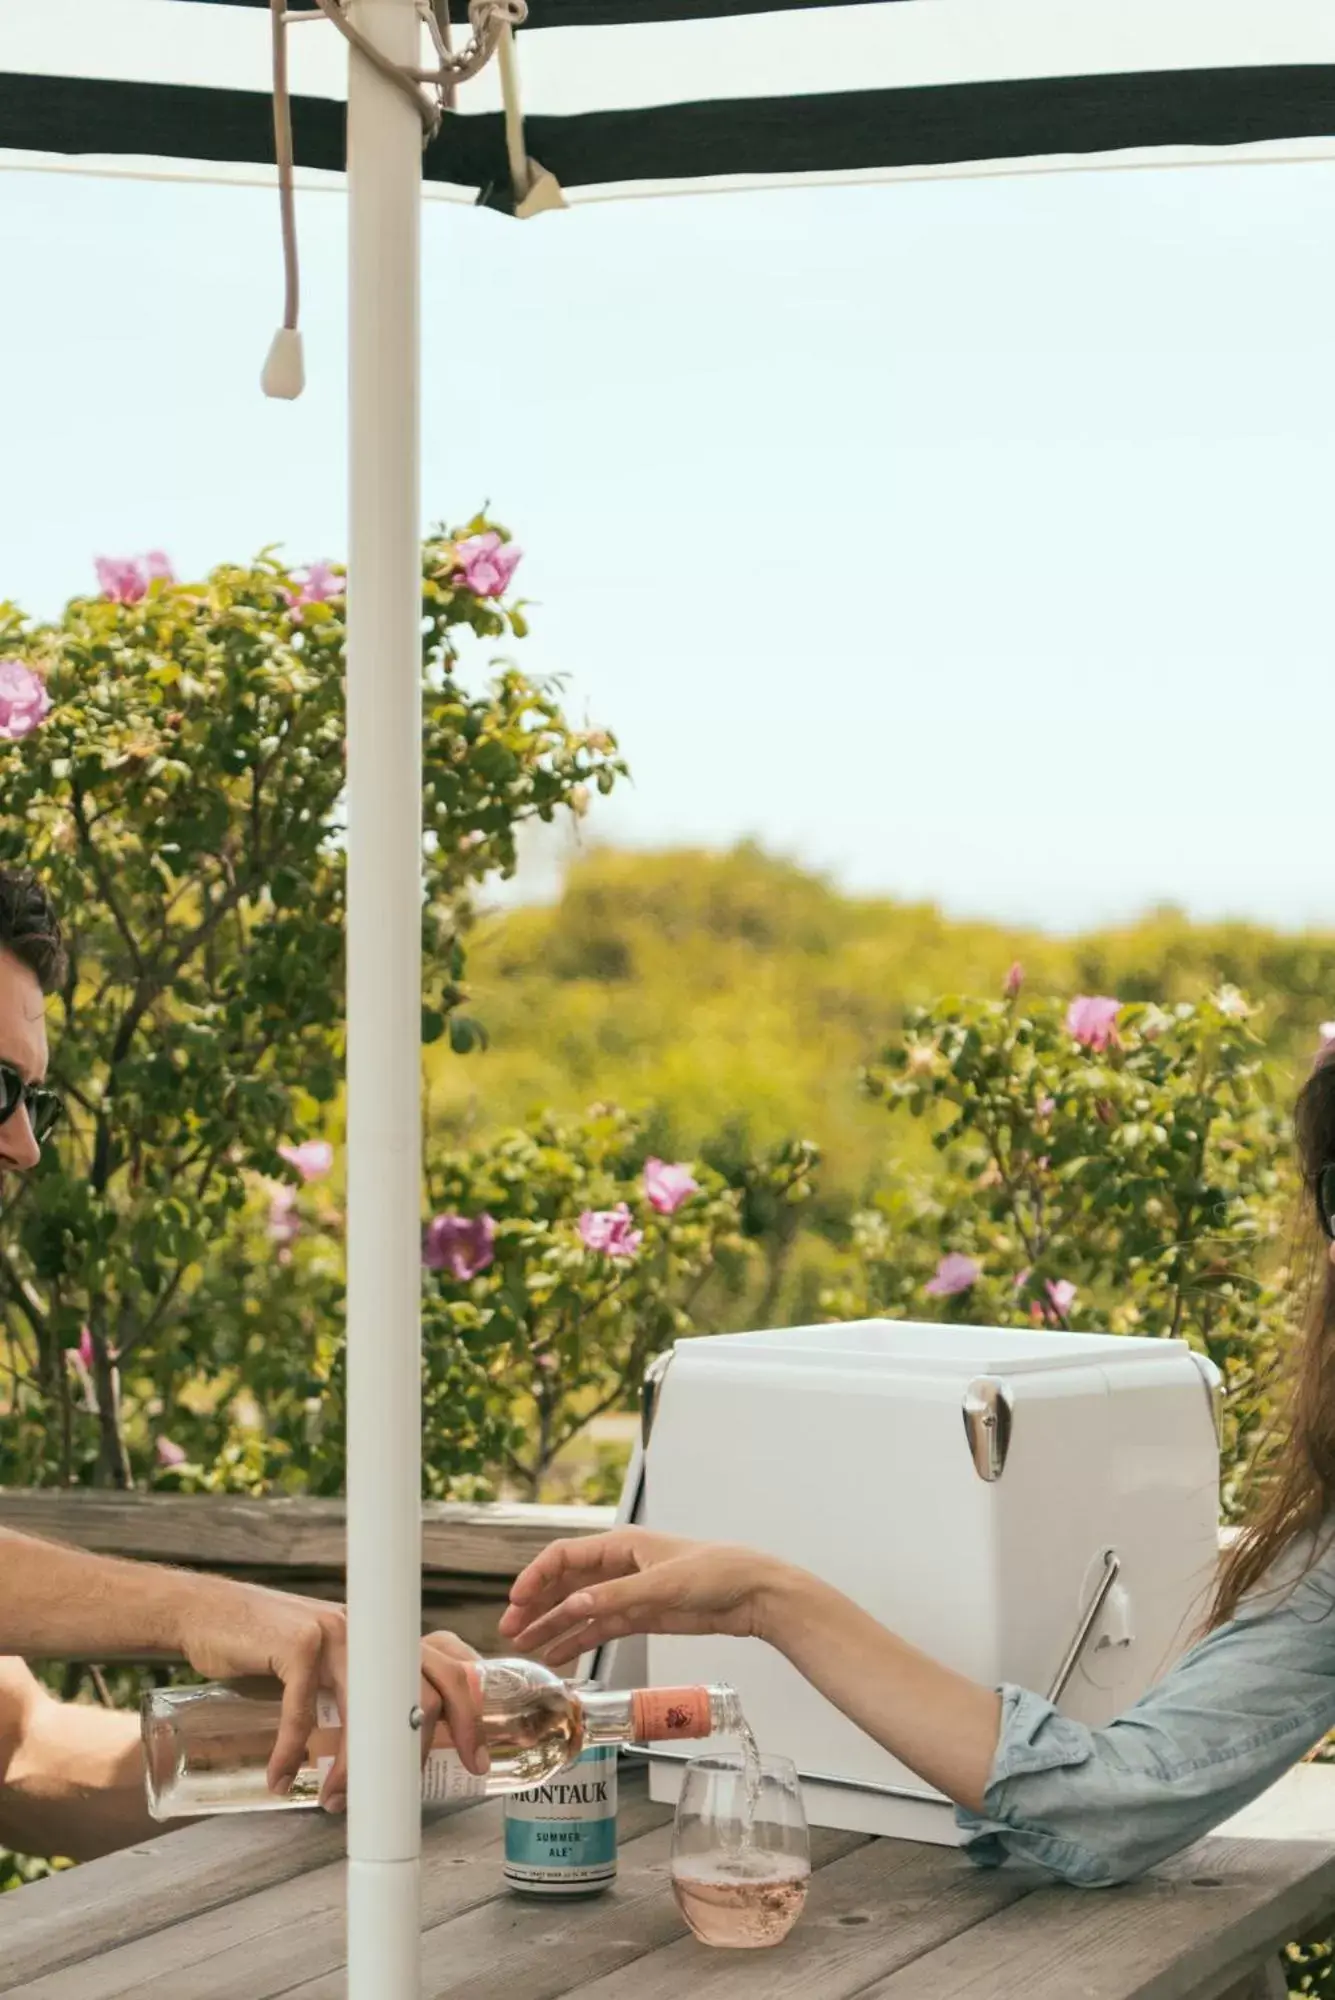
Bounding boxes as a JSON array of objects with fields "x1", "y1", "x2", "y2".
[{"x1": 506, "y1": 1744, "x2": 618, "y2": 1896}]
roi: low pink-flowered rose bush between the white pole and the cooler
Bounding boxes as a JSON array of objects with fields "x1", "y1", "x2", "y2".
[{"x1": 424, "y1": 1106, "x2": 817, "y2": 1498}]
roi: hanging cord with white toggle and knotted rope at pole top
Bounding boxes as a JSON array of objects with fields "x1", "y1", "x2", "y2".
[{"x1": 260, "y1": 0, "x2": 531, "y2": 402}]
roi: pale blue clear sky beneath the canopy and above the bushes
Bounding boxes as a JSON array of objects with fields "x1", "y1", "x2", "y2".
[{"x1": 0, "y1": 152, "x2": 1335, "y2": 930}]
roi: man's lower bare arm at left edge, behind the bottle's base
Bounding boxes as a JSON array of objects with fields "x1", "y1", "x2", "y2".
[{"x1": 0, "y1": 1658, "x2": 166, "y2": 1862}]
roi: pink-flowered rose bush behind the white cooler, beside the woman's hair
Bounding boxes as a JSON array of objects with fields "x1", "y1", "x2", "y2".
[{"x1": 825, "y1": 980, "x2": 1295, "y2": 1510}]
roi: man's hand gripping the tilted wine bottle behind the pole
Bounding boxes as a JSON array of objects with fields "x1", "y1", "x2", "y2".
[{"x1": 163, "y1": 1576, "x2": 488, "y2": 1812}]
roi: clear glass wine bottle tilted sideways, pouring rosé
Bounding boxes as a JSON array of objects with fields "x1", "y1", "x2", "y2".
[{"x1": 142, "y1": 1660, "x2": 741, "y2": 1820}]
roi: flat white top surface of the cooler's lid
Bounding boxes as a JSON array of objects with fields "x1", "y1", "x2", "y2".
[{"x1": 677, "y1": 1320, "x2": 1185, "y2": 1376}]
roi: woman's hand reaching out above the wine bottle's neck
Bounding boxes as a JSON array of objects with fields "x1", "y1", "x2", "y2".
[{"x1": 500, "y1": 1528, "x2": 781, "y2": 1666}]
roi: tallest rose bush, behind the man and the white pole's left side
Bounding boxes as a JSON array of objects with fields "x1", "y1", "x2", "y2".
[{"x1": 0, "y1": 520, "x2": 622, "y2": 1484}]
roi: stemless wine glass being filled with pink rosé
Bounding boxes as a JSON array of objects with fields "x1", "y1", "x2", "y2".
[{"x1": 671, "y1": 1754, "x2": 811, "y2": 1950}]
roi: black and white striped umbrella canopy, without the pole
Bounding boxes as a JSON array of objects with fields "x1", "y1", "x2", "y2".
[{"x1": 0, "y1": 0, "x2": 1335, "y2": 196}]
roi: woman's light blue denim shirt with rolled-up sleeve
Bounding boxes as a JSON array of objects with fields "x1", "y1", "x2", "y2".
[{"x1": 955, "y1": 1538, "x2": 1335, "y2": 1888}]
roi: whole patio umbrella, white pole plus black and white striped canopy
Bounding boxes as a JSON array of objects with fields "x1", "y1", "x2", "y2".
[{"x1": 0, "y1": 0, "x2": 1335, "y2": 2000}]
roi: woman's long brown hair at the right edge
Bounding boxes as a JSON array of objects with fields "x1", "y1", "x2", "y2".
[{"x1": 1209, "y1": 1046, "x2": 1335, "y2": 1626}]
